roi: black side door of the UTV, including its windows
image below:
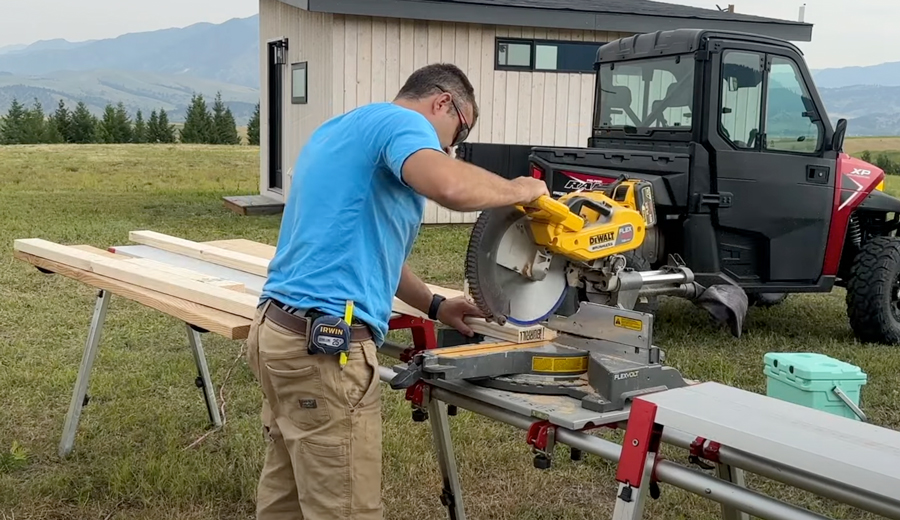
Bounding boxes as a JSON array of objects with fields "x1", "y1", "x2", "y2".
[{"x1": 706, "y1": 44, "x2": 837, "y2": 290}]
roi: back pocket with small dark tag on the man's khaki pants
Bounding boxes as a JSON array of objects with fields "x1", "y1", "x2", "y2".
[{"x1": 266, "y1": 363, "x2": 331, "y2": 430}]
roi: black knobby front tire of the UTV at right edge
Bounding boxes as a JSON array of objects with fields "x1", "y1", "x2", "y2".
[{"x1": 846, "y1": 237, "x2": 900, "y2": 345}]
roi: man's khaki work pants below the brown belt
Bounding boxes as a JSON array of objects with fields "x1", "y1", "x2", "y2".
[{"x1": 247, "y1": 304, "x2": 382, "y2": 520}]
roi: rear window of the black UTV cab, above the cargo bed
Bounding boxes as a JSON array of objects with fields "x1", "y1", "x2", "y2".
[{"x1": 595, "y1": 56, "x2": 694, "y2": 133}]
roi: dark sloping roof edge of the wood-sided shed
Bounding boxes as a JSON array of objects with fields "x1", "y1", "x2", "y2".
[{"x1": 281, "y1": 0, "x2": 813, "y2": 41}]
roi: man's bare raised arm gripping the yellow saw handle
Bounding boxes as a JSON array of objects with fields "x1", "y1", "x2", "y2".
[{"x1": 403, "y1": 149, "x2": 549, "y2": 211}]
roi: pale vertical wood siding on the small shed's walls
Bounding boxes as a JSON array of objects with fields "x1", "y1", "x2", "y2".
[{"x1": 260, "y1": 6, "x2": 625, "y2": 224}]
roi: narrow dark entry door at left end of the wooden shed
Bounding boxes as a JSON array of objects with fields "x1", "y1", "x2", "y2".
[{"x1": 266, "y1": 40, "x2": 287, "y2": 192}]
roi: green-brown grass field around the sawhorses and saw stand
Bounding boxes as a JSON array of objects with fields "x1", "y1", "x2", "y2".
[{"x1": 0, "y1": 145, "x2": 900, "y2": 520}]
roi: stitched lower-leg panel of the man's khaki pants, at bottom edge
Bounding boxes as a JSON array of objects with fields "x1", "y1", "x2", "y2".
[{"x1": 294, "y1": 440, "x2": 351, "y2": 520}]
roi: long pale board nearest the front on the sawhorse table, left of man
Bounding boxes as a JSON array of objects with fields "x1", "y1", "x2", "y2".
[{"x1": 13, "y1": 238, "x2": 259, "y2": 318}]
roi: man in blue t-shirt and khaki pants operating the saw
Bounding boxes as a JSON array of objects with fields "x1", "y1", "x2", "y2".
[{"x1": 247, "y1": 64, "x2": 548, "y2": 520}]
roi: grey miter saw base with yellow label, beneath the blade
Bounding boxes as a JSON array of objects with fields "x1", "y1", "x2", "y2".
[{"x1": 391, "y1": 303, "x2": 687, "y2": 416}]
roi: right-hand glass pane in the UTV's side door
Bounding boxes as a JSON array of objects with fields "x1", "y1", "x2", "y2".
[{"x1": 765, "y1": 56, "x2": 822, "y2": 153}]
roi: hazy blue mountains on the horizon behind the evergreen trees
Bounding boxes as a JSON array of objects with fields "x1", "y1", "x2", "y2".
[{"x1": 0, "y1": 15, "x2": 900, "y2": 135}]
